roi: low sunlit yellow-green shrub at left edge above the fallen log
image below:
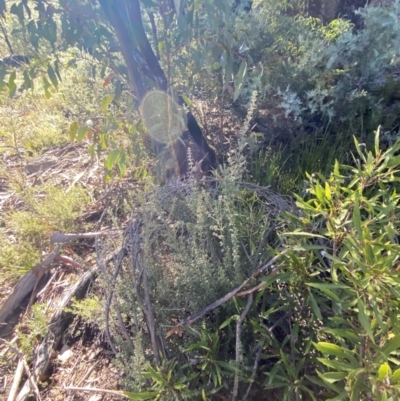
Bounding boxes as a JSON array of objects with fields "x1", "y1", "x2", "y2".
[{"x1": 0, "y1": 185, "x2": 89, "y2": 283}]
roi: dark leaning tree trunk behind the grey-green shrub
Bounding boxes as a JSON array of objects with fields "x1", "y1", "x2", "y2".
[{"x1": 99, "y1": 0, "x2": 216, "y2": 175}]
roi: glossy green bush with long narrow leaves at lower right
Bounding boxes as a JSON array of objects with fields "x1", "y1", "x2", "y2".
[{"x1": 121, "y1": 130, "x2": 400, "y2": 401}]
